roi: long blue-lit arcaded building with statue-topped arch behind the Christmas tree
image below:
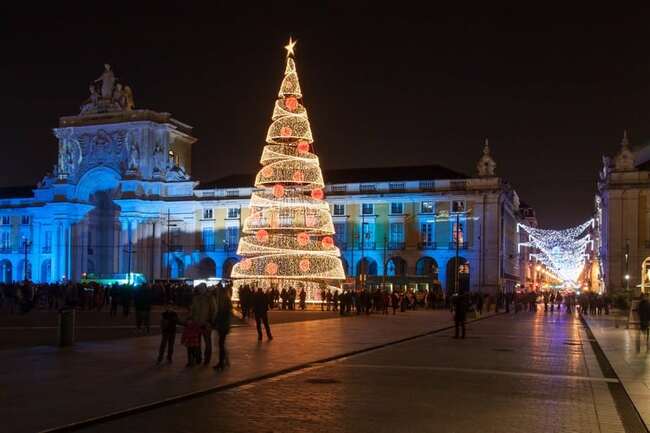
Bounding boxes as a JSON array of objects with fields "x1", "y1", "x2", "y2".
[{"x1": 0, "y1": 71, "x2": 521, "y2": 292}]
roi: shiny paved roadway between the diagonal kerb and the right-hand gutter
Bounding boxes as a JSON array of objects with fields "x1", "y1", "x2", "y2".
[{"x1": 87, "y1": 312, "x2": 640, "y2": 433}]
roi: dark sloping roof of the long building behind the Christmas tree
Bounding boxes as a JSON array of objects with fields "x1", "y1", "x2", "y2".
[{"x1": 197, "y1": 164, "x2": 470, "y2": 189}]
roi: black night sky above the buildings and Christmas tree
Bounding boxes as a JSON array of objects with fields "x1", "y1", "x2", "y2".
[{"x1": 0, "y1": 1, "x2": 650, "y2": 228}]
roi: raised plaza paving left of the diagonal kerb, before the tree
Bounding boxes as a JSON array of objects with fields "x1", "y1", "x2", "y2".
[{"x1": 0, "y1": 311, "x2": 458, "y2": 433}]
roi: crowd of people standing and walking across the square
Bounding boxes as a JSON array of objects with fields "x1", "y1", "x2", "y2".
[{"x1": 0, "y1": 276, "x2": 650, "y2": 362}]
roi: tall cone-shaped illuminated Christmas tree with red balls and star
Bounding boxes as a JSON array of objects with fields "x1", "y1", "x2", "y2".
[{"x1": 232, "y1": 39, "x2": 345, "y2": 300}]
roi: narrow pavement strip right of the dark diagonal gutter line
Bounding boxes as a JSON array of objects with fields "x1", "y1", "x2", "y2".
[{"x1": 585, "y1": 316, "x2": 650, "y2": 426}]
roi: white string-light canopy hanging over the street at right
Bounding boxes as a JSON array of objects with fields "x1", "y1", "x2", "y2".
[{"x1": 517, "y1": 219, "x2": 594, "y2": 285}]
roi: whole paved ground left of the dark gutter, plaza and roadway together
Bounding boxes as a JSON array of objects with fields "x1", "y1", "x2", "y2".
[{"x1": 0, "y1": 311, "x2": 647, "y2": 433}]
